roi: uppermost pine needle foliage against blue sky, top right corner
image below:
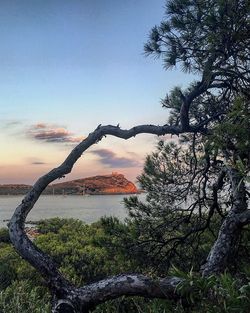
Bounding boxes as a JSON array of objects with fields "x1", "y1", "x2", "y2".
[{"x1": 145, "y1": 0, "x2": 250, "y2": 79}]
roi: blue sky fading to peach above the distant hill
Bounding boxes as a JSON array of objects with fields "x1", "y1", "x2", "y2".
[{"x1": 0, "y1": 0, "x2": 193, "y2": 184}]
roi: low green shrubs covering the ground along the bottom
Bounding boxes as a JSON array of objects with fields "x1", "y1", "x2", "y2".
[{"x1": 0, "y1": 218, "x2": 250, "y2": 313}]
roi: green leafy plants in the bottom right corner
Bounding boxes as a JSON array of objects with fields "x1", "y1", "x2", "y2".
[{"x1": 172, "y1": 268, "x2": 250, "y2": 313}]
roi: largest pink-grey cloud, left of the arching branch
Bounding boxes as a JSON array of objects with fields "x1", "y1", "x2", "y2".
[{"x1": 27, "y1": 123, "x2": 83, "y2": 143}]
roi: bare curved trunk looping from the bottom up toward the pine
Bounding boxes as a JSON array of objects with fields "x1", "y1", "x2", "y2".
[{"x1": 8, "y1": 125, "x2": 188, "y2": 312}]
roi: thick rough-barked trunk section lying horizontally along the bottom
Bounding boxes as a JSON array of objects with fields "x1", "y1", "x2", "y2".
[{"x1": 52, "y1": 274, "x2": 183, "y2": 313}]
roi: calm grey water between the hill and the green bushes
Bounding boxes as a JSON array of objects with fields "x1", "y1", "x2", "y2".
[{"x1": 0, "y1": 194, "x2": 145, "y2": 227}]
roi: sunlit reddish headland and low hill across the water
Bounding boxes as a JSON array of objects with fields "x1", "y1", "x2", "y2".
[{"x1": 0, "y1": 173, "x2": 138, "y2": 195}]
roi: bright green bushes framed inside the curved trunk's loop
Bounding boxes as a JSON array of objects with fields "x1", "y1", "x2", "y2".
[{"x1": 36, "y1": 218, "x2": 138, "y2": 286}]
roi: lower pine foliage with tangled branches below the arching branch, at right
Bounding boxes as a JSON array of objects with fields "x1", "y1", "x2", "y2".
[{"x1": 125, "y1": 99, "x2": 250, "y2": 275}]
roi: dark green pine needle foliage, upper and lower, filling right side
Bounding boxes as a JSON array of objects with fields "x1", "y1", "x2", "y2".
[{"x1": 125, "y1": 0, "x2": 250, "y2": 278}]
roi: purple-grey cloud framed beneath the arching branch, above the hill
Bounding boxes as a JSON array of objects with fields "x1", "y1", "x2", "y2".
[{"x1": 92, "y1": 149, "x2": 141, "y2": 168}]
